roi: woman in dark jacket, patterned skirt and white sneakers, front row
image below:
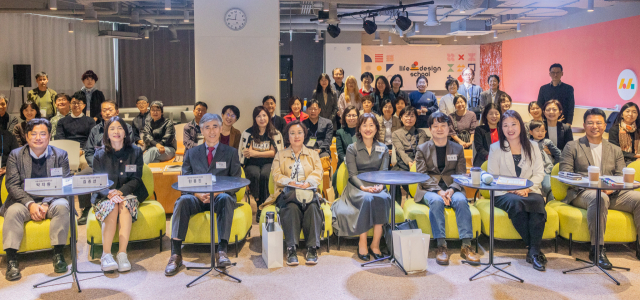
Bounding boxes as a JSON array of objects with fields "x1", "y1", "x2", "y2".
[{"x1": 91, "y1": 116, "x2": 149, "y2": 272}]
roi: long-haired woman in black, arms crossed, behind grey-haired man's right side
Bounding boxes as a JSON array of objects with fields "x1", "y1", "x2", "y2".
[{"x1": 238, "y1": 106, "x2": 283, "y2": 222}]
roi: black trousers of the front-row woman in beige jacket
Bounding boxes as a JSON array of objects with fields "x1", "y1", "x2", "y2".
[{"x1": 276, "y1": 192, "x2": 324, "y2": 248}]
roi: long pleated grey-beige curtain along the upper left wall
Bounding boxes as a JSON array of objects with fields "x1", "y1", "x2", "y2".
[{"x1": 0, "y1": 14, "x2": 116, "y2": 113}]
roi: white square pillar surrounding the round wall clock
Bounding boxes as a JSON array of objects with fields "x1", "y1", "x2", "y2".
[{"x1": 194, "y1": 0, "x2": 280, "y2": 131}]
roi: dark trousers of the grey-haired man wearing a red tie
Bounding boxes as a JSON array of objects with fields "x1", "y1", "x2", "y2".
[{"x1": 171, "y1": 193, "x2": 236, "y2": 242}]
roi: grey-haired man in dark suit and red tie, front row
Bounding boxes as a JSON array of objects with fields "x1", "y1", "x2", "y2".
[{"x1": 164, "y1": 113, "x2": 242, "y2": 276}]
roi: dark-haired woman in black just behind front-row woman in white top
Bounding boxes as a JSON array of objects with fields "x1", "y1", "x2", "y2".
[{"x1": 473, "y1": 103, "x2": 502, "y2": 168}]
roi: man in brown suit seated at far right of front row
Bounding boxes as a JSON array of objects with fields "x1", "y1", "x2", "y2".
[{"x1": 560, "y1": 108, "x2": 640, "y2": 270}]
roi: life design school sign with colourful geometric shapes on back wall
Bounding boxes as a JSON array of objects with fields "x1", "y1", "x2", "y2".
[{"x1": 356, "y1": 45, "x2": 480, "y2": 90}]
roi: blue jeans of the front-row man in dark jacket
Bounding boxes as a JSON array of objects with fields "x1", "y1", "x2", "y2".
[{"x1": 423, "y1": 192, "x2": 473, "y2": 239}]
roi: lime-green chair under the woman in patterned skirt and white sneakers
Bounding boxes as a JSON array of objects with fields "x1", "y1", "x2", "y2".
[{"x1": 87, "y1": 165, "x2": 167, "y2": 259}]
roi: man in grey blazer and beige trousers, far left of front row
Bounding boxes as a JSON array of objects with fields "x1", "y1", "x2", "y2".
[{"x1": 0, "y1": 118, "x2": 69, "y2": 281}]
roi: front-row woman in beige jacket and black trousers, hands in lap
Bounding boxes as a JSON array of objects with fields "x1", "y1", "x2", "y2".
[{"x1": 260, "y1": 119, "x2": 322, "y2": 266}]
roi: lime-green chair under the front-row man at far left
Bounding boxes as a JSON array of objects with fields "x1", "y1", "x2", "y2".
[{"x1": 0, "y1": 176, "x2": 78, "y2": 254}]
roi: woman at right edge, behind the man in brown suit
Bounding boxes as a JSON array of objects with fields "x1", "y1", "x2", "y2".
[{"x1": 609, "y1": 102, "x2": 640, "y2": 166}]
